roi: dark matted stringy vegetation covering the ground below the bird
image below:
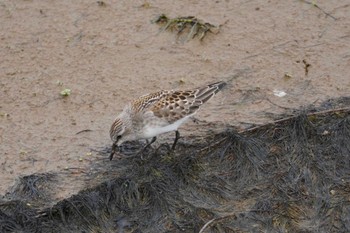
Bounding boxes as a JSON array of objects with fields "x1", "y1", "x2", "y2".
[{"x1": 0, "y1": 98, "x2": 350, "y2": 232}]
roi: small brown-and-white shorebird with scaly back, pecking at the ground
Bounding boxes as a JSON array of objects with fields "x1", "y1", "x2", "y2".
[{"x1": 109, "y1": 82, "x2": 226, "y2": 160}]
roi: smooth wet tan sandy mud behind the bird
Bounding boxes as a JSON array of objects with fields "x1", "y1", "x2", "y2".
[{"x1": 0, "y1": 0, "x2": 350, "y2": 197}]
